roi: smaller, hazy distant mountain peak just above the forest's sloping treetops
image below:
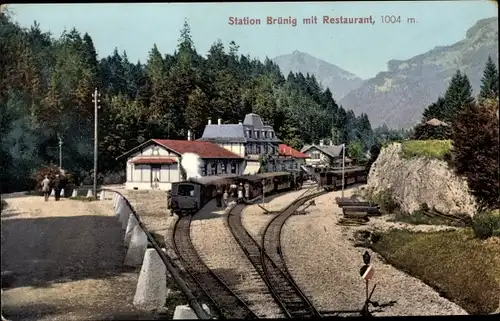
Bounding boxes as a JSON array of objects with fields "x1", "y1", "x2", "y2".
[{"x1": 273, "y1": 50, "x2": 363, "y2": 101}]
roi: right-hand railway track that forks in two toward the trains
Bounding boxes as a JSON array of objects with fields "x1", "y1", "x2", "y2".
[{"x1": 227, "y1": 190, "x2": 326, "y2": 318}]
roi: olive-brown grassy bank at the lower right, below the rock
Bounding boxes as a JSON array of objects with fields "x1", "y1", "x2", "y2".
[{"x1": 373, "y1": 229, "x2": 500, "y2": 314}]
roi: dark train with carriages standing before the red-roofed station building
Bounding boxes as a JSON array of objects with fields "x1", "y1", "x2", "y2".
[{"x1": 170, "y1": 172, "x2": 303, "y2": 214}]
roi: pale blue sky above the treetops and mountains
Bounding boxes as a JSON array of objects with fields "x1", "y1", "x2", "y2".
[{"x1": 8, "y1": 0, "x2": 498, "y2": 79}]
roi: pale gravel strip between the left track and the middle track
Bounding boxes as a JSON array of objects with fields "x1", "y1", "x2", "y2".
[{"x1": 191, "y1": 201, "x2": 281, "y2": 318}]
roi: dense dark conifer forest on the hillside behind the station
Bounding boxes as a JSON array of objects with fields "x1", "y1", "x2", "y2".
[{"x1": 0, "y1": 10, "x2": 404, "y2": 192}]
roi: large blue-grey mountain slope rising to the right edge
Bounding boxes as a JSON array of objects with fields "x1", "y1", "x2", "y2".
[{"x1": 340, "y1": 17, "x2": 498, "y2": 128}]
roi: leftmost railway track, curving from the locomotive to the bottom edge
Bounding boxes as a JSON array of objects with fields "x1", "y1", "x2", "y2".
[{"x1": 173, "y1": 210, "x2": 257, "y2": 319}]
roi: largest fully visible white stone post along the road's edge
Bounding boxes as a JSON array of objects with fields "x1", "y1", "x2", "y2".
[{"x1": 133, "y1": 249, "x2": 169, "y2": 308}]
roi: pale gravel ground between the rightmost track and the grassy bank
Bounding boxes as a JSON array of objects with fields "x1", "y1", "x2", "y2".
[{"x1": 282, "y1": 190, "x2": 467, "y2": 316}]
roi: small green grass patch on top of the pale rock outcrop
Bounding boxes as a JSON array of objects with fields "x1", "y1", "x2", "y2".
[{"x1": 401, "y1": 140, "x2": 451, "y2": 160}]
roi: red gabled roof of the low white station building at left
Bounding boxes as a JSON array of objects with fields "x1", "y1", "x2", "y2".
[{"x1": 117, "y1": 139, "x2": 242, "y2": 159}]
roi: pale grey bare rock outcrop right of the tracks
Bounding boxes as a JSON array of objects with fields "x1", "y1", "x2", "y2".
[{"x1": 366, "y1": 143, "x2": 477, "y2": 216}]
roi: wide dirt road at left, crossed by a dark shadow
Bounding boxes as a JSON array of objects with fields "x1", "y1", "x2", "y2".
[{"x1": 1, "y1": 196, "x2": 164, "y2": 321}]
